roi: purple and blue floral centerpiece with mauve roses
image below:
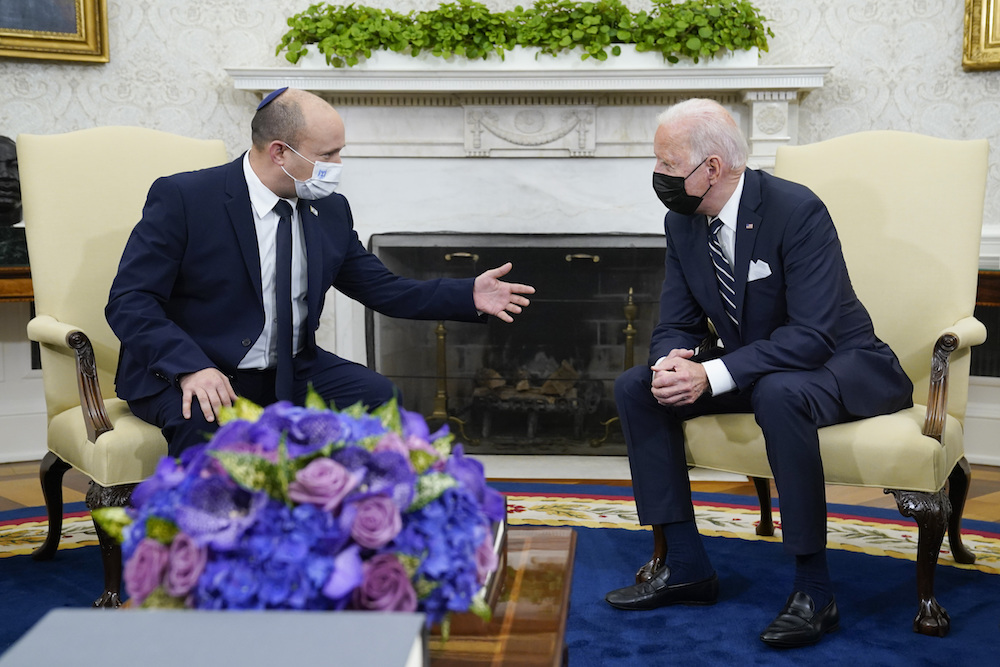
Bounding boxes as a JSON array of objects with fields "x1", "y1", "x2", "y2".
[{"x1": 98, "y1": 393, "x2": 506, "y2": 634}]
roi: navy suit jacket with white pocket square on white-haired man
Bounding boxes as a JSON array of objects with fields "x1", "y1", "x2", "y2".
[{"x1": 650, "y1": 169, "x2": 913, "y2": 417}]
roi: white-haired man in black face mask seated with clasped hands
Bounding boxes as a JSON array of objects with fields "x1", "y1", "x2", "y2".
[{"x1": 606, "y1": 99, "x2": 913, "y2": 647}]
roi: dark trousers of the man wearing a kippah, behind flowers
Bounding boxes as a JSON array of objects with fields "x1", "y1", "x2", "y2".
[{"x1": 128, "y1": 349, "x2": 401, "y2": 456}]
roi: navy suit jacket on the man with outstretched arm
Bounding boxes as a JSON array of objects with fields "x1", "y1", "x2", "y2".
[{"x1": 105, "y1": 158, "x2": 480, "y2": 400}]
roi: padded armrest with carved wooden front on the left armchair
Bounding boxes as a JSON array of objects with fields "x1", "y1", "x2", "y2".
[{"x1": 28, "y1": 315, "x2": 114, "y2": 442}]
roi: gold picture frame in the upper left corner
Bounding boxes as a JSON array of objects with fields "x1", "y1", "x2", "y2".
[{"x1": 0, "y1": 0, "x2": 110, "y2": 63}]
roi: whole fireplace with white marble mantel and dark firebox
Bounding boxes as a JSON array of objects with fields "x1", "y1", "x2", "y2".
[{"x1": 226, "y1": 58, "x2": 830, "y2": 454}]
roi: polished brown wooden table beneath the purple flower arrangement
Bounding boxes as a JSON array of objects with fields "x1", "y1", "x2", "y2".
[{"x1": 429, "y1": 526, "x2": 576, "y2": 667}]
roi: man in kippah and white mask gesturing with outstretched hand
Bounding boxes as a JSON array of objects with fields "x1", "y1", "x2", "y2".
[{"x1": 106, "y1": 89, "x2": 534, "y2": 455}]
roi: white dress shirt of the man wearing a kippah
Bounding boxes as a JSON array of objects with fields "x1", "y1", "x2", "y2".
[{"x1": 239, "y1": 153, "x2": 307, "y2": 370}]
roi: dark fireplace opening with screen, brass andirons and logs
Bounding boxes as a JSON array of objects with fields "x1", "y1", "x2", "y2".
[{"x1": 366, "y1": 233, "x2": 663, "y2": 454}]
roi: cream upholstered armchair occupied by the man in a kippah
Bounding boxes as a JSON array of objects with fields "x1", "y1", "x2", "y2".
[{"x1": 17, "y1": 127, "x2": 227, "y2": 607}]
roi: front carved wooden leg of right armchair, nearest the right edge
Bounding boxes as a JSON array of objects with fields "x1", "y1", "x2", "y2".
[{"x1": 886, "y1": 489, "x2": 951, "y2": 637}]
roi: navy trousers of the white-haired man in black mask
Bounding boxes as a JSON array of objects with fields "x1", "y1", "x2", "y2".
[{"x1": 615, "y1": 366, "x2": 855, "y2": 554}]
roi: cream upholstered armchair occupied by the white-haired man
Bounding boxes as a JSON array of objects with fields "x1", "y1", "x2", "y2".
[{"x1": 684, "y1": 131, "x2": 989, "y2": 636}]
